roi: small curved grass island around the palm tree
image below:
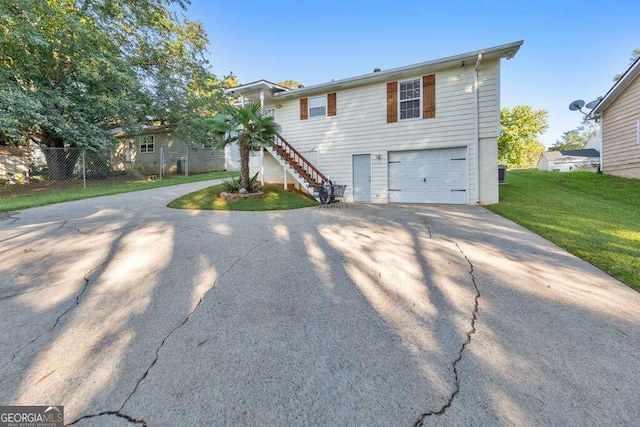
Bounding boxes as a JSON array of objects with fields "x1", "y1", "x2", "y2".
[{"x1": 168, "y1": 185, "x2": 318, "y2": 211}]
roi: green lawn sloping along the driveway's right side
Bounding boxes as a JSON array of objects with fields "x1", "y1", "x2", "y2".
[{"x1": 487, "y1": 170, "x2": 640, "y2": 291}]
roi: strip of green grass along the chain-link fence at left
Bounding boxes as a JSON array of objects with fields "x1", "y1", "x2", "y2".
[{"x1": 0, "y1": 172, "x2": 239, "y2": 212}]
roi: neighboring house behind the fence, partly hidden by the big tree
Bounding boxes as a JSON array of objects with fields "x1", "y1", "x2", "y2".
[{"x1": 112, "y1": 126, "x2": 240, "y2": 175}]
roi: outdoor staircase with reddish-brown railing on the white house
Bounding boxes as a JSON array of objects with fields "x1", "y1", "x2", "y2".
[{"x1": 268, "y1": 134, "x2": 329, "y2": 196}]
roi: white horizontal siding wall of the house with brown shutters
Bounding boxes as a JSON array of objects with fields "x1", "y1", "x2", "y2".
[{"x1": 264, "y1": 61, "x2": 499, "y2": 203}]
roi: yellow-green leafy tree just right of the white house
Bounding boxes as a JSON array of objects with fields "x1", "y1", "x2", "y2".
[{"x1": 498, "y1": 105, "x2": 548, "y2": 168}]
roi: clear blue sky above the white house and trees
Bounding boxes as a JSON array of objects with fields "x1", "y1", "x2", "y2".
[{"x1": 180, "y1": 0, "x2": 640, "y2": 146}]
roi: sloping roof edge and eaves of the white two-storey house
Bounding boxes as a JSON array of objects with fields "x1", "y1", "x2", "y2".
[{"x1": 227, "y1": 40, "x2": 524, "y2": 99}]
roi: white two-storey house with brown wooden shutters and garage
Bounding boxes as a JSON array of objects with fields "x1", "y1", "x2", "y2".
[{"x1": 228, "y1": 41, "x2": 522, "y2": 204}]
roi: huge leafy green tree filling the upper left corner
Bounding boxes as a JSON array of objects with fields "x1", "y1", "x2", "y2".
[{"x1": 0, "y1": 0, "x2": 222, "y2": 179}]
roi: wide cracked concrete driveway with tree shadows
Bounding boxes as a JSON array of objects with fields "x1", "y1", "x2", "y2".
[{"x1": 0, "y1": 183, "x2": 640, "y2": 426}]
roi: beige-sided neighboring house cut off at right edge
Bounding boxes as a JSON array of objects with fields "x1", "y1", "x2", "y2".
[{"x1": 589, "y1": 55, "x2": 640, "y2": 178}]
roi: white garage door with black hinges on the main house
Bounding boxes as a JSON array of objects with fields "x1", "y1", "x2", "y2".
[{"x1": 389, "y1": 147, "x2": 469, "y2": 204}]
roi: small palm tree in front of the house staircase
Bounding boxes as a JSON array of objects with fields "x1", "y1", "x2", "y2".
[{"x1": 207, "y1": 103, "x2": 280, "y2": 189}]
